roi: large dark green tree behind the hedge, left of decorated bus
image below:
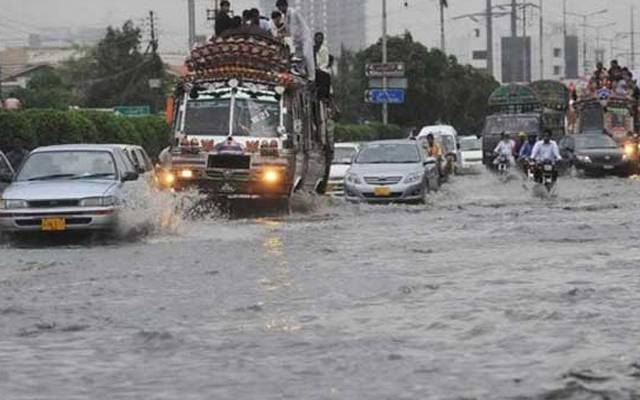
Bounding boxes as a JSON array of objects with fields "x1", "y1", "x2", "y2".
[{"x1": 65, "y1": 21, "x2": 168, "y2": 110}]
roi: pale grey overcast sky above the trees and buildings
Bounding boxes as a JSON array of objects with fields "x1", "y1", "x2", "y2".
[{"x1": 0, "y1": 0, "x2": 640, "y2": 52}]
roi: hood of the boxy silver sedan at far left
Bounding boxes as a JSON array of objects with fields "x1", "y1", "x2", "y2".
[{"x1": 2, "y1": 180, "x2": 117, "y2": 200}]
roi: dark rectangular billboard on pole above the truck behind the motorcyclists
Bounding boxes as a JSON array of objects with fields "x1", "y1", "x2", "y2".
[{"x1": 502, "y1": 36, "x2": 531, "y2": 83}]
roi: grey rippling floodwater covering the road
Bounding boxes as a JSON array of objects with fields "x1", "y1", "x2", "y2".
[{"x1": 0, "y1": 175, "x2": 640, "y2": 400}]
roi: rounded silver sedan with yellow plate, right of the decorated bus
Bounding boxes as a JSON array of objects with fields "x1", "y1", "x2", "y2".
[{"x1": 345, "y1": 140, "x2": 439, "y2": 203}]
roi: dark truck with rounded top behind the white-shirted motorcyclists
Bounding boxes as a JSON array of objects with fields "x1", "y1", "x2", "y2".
[{"x1": 482, "y1": 84, "x2": 543, "y2": 166}]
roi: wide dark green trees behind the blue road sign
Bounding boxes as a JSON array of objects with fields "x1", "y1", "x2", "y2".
[{"x1": 335, "y1": 33, "x2": 498, "y2": 134}]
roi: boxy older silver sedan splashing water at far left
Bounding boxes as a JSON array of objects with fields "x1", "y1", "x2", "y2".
[{"x1": 0, "y1": 145, "x2": 138, "y2": 232}]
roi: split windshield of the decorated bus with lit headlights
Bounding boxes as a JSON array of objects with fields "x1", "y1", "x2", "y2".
[{"x1": 184, "y1": 94, "x2": 280, "y2": 137}]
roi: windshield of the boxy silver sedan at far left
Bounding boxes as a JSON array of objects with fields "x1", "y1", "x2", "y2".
[{"x1": 17, "y1": 151, "x2": 117, "y2": 181}]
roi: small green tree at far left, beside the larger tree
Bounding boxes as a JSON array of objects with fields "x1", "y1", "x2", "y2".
[{"x1": 15, "y1": 68, "x2": 77, "y2": 110}]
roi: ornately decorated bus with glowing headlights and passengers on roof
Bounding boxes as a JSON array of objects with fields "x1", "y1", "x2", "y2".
[{"x1": 159, "y1": 29, "x2": 334, "y2": 208}]
